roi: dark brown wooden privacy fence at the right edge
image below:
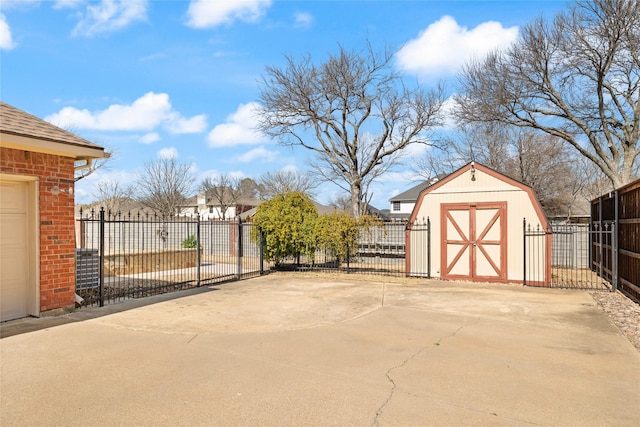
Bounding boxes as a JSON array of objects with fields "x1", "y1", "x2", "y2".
[{"x1": 591, "y1": 180, "x2": 640, "y2": 299}]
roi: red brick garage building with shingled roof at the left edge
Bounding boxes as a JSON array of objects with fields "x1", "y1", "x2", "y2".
[{"x1": 0, "y1": 102, "x2": 107, "y2": 321}]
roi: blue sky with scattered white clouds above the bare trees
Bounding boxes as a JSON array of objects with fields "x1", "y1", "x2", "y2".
[{"x1": 0, "y1": 0, "x2": 566, "y2": 209}]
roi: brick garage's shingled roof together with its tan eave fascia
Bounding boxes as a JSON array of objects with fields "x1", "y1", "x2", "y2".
[{"x1": 0, "y1": 101, "x2": 106, "y2": 159}]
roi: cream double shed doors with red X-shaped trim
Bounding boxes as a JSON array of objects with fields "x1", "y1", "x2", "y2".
[{"x1": 440, "y1": 202, "x2": 507, "y2": 282}]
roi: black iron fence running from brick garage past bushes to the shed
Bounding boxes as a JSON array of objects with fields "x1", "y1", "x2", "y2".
[{"x1": 76, "y1": 209, "x2": 420, "y2": 306}]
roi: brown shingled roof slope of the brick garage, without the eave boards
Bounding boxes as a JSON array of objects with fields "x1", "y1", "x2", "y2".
[{"x1": 0, "y1": 101, "x2": 104, "y2": 157}]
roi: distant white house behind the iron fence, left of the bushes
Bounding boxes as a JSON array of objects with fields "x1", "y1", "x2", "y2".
[{"x1": 180, "y1": 191, "x2": 262, "y2": 221}]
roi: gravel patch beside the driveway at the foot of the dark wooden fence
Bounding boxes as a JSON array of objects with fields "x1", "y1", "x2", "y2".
[{"x1": 591, "y1": 291, "x2": 640, "y2": 352}]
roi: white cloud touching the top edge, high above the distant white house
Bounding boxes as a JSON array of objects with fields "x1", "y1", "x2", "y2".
[{"x1": 187, "y1": 0, "x2": 271, "y2": 28}]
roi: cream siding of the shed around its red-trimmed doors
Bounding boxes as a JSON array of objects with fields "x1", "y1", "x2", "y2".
[{"x1": 409, "y1": 165, "x2": 546, "y2": 282}]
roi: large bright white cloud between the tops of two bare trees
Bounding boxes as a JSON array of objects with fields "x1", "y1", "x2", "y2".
[{"x1": 397, "y1": 16, "x2": 518, "y2": 76}]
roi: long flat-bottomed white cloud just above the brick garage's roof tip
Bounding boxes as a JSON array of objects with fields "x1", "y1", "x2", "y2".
[{"x1": 45, "y1": 92, "x2": 206, "y2": 134}]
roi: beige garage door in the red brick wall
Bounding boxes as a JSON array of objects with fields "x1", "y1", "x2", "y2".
[{"x1": 0, "y1": 181, "x2": 30, "y2": 321}]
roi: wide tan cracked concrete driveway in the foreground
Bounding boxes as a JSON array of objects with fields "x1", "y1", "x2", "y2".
[{"x1": 0, "y1": 274, "x2": 640, "y2": 426}]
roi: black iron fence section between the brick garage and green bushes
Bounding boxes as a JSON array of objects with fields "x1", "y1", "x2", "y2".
[{"x1": 76, "y1": 209, "x2": 269, "y2": 306}]
